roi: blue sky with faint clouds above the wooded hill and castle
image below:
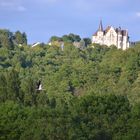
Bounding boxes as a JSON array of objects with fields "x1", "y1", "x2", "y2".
[{"x1": 0, "y1": 0, "x2": 140, "y2": 44}]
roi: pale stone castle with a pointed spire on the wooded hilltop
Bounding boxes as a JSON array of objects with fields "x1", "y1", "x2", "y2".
[{"x1": 92, "y1": 21, "x2": 129, "y2": 50}]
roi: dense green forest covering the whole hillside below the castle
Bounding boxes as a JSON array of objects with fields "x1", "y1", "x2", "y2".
[{"x1": 0, "y1": 29, "x2": 140, "y2": 140}]
